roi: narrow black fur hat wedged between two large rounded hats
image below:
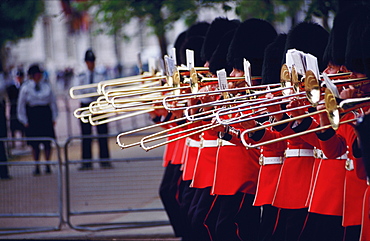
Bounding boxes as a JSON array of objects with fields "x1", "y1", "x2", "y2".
[{"x1": 262, "y1": 34, "x2": 287, "y2": 84}]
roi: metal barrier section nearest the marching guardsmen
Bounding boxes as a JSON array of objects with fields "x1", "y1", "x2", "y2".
[{"x1": 64, "y1": 135, "x2": 169, "y2": 231}]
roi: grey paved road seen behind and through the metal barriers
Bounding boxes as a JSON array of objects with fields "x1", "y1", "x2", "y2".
[{"x1": 0, "y1": 92, "x2": 179, "y2": 240}]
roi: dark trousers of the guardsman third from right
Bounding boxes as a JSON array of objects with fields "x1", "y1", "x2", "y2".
[{"x1": 274, "y1": 208, "x2": 308, "y2": 241}]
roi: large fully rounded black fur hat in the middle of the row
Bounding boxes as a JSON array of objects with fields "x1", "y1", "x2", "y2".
[{"x1": 227, "y1": 18, "x2": 277, "y2": 76}]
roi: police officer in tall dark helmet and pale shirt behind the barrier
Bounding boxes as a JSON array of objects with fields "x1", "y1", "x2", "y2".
[{"x1": 77, "y1": 49, "x2": 112, "y2": 171}]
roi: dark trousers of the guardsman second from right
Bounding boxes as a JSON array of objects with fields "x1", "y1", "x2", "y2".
[{"x1": 299, "y1": 213, "x2": 344, "y2": 241}]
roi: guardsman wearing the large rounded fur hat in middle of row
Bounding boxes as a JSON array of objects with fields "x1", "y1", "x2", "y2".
[{"x1": 210, "y1": 18, "x2": 277, "y2": 240}]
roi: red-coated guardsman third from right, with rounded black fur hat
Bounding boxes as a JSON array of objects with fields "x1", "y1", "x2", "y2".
[{"x1": 272, "y1": 22, "x2": 328, "y2": 240}]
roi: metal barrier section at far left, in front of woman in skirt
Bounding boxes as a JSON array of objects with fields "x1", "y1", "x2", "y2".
[{"x1": 0, "y1": 137, "x2": 63, "y2": 235}]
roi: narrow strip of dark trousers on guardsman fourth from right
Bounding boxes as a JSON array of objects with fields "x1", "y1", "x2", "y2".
[{"x1": 258, "y1": 204, "x2": 279, "y2": 241}]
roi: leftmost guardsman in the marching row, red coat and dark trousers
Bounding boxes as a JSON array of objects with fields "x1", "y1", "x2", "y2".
[{"x1": 153, "y1": 22, "x2": 209, "y2": 240}]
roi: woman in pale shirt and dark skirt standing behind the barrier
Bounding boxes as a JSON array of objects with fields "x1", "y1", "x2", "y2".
[{"x1": 17, "y1": 64, "x2": 58, "y2": 175}]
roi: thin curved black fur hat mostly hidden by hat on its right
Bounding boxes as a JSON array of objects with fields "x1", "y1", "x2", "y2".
[{"x1": 201, "y1": 17, "x2": 240, "y2": 61}]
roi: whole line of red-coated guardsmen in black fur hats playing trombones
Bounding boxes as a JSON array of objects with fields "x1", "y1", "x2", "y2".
[{"x1": 151, "y1": 6, "x2": 370, "y2": 241}]
